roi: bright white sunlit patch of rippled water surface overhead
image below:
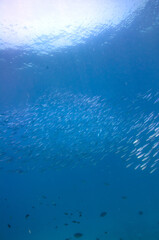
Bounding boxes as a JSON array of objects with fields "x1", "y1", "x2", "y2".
[{"x1": 0, "y1": 0, "x2": 148, "y2": 52}]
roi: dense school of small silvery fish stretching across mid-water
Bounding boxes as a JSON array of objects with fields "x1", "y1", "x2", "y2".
[{"x1": 0, "y1": 91, "x2": 159, "y2": 173}]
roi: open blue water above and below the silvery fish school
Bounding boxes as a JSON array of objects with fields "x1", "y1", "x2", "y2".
[{"x1": 0, "y1": 0, "x2": 159, "y2": 240}]
